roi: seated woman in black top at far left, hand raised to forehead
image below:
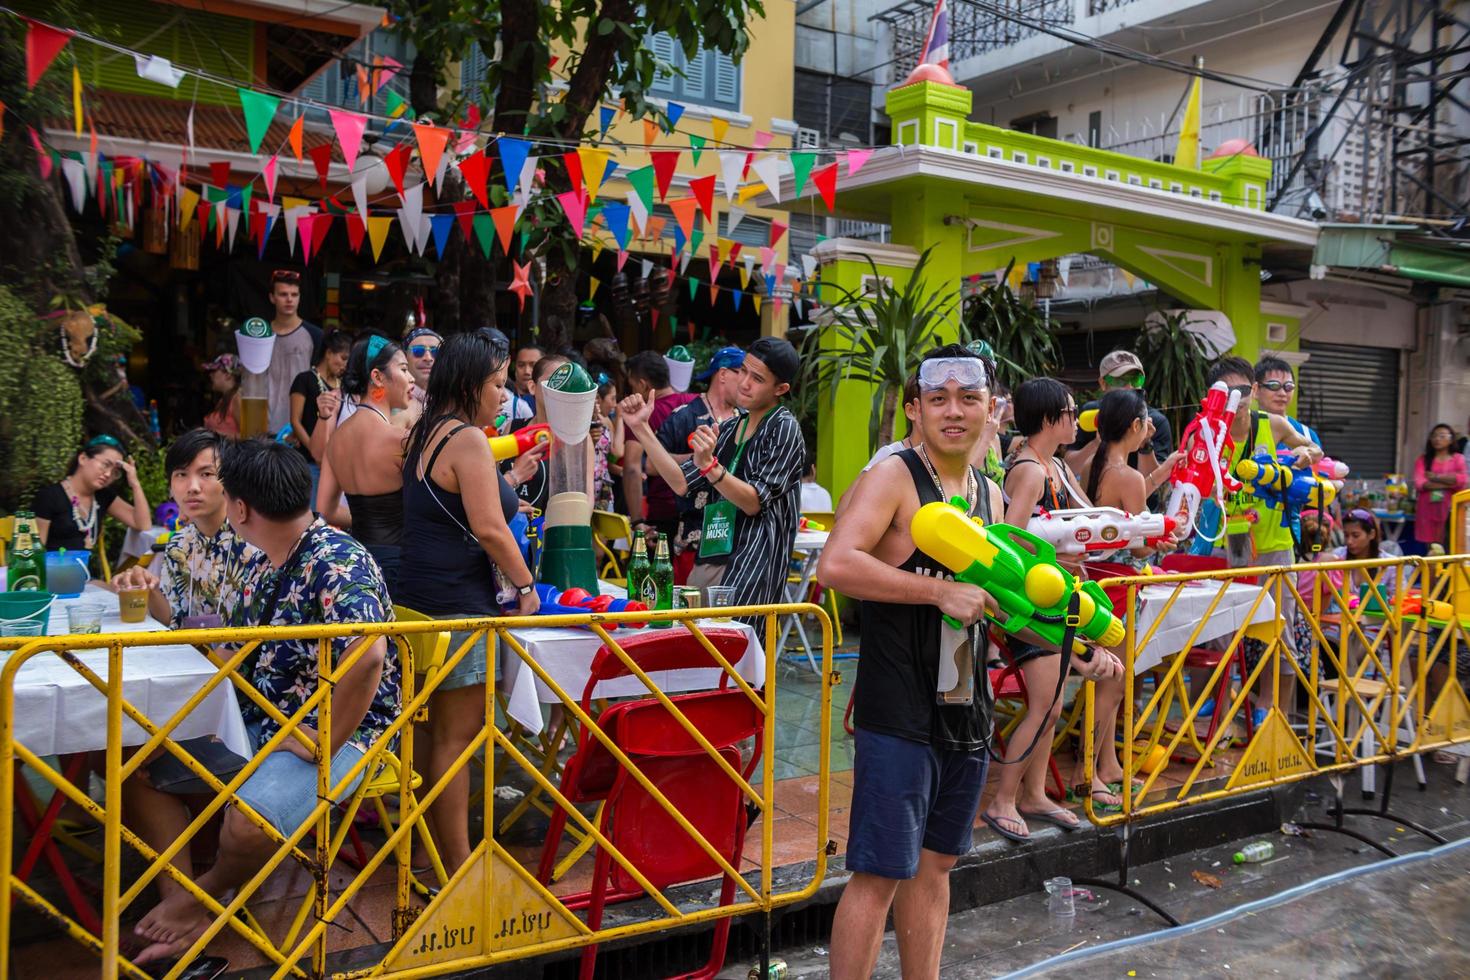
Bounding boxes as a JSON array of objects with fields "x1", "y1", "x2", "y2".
[{"x1": 31, "y1": 435, "x2": 153, "y2": 552}]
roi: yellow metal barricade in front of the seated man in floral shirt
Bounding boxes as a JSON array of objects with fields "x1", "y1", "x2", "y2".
[{"x1": 0, "y1": 604, "x2": 838, "y2": 979}]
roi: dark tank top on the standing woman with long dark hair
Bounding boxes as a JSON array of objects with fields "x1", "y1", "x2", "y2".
[{"x1": 394, "y1": 423, "x2": 517, "y2": 616}]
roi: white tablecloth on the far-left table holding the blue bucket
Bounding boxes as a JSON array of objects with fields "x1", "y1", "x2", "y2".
[{"x1": 0, "y1": 585, "x2": 254, "y2": 757}]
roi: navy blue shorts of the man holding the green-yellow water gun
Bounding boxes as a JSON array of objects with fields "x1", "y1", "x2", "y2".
[{"x1": 847, "y1": 727, "x2": 989, "y2": 879}]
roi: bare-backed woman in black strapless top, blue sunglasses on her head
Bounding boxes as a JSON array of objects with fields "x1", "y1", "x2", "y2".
[{"x1": 316, "y1": 335, "x2": 413, "y2": 594}]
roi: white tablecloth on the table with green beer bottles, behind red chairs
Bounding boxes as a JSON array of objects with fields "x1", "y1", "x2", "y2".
[{"x1": 498, "y1": 620, "x2": 766, "y2": 732}]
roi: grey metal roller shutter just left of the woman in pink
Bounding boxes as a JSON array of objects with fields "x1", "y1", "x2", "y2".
[{"x1": 1297, "y1": 341, "x2": 1399, "y2": 479}]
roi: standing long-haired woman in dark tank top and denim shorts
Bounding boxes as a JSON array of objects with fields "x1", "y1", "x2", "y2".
[{"x1": 394, "y1": 332, "x2": 541, "y2": 873}]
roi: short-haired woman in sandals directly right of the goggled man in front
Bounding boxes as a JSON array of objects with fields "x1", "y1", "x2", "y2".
[{"x1": 985, "y1": 378, "x2": 1122, "y2": 840}]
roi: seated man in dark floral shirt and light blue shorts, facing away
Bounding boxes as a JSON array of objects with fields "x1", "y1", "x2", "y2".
[{"x1": 134, "y1": 441, "x2": 401, "y2": 964}]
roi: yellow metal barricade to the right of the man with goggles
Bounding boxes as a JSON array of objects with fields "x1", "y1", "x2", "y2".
[{"x1": 1082, "y1": 557, "x2": 1470, "y2": 826}]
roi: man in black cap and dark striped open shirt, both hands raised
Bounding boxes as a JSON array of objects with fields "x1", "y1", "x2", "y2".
[{"x1": 619, "y1": 336, "x2": 807, "y2": 624}]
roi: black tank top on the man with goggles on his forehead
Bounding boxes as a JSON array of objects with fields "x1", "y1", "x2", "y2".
[{"x1": 853, "y1": 450, "x2": 991, "y2": 752}]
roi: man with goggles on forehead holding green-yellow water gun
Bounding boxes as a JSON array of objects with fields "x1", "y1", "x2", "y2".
[{"x1": 817, "y1": 345, "x2": 1122, "y2": 980}]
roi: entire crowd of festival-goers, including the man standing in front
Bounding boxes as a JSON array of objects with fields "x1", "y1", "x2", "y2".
[{"x1": 25, "y1": 262, "x2": 1467, "y2": 977}]
